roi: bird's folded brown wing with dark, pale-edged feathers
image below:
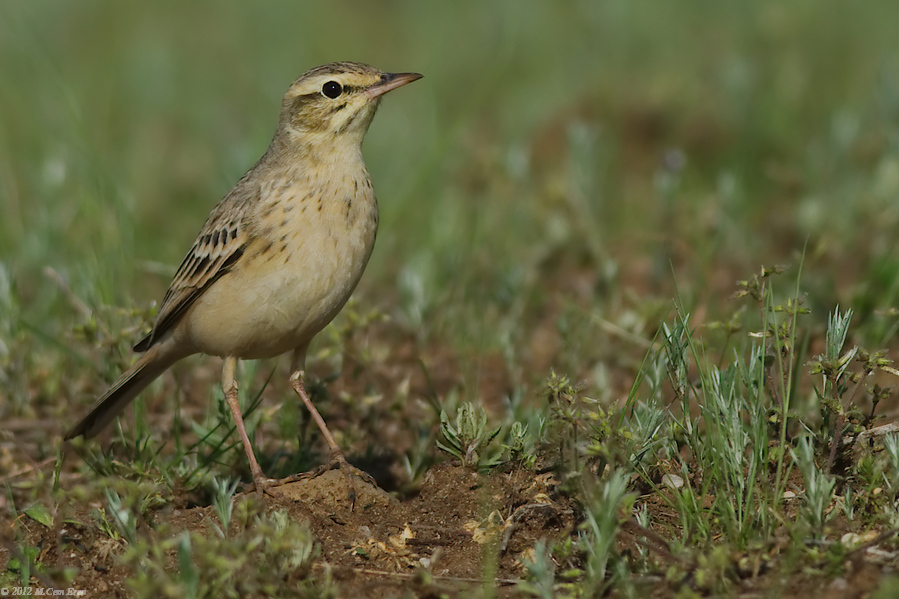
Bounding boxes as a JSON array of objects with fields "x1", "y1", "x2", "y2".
[{"x1": 134, "y1": 183, "x2": 259, "y2": 351}]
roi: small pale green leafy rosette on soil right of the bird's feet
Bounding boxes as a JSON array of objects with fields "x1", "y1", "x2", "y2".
[{"x1": 437, "y1": 402, "x2": 502, "y2": 470}]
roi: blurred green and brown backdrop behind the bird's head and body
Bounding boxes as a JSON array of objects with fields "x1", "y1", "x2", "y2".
[{"x1": 0, "y1": 0, "x2": 899, "y2": 414}]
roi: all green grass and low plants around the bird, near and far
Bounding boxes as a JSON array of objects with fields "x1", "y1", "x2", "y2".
[{"x1": 0, "y1": 0, "x2": 899, "y2": 596}]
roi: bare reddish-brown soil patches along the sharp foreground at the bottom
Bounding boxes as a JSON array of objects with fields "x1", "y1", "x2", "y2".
[{"x1": 7, "y1": 454, "x2": 895, "y2": 599}]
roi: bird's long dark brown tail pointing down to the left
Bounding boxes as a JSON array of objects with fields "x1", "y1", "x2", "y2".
[{"x1": 65, "y1": 343, "x2": 184, "y2": 441}]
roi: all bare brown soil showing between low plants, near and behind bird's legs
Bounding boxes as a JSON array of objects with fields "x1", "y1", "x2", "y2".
[{"x1": 0, "y1": 290, "x2": 899, "y2": 599}]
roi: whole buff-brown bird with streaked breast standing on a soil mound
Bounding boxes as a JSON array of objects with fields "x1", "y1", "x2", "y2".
[{"x1": 66, "y1": 62, "x2": 421, "y2": 494}]
